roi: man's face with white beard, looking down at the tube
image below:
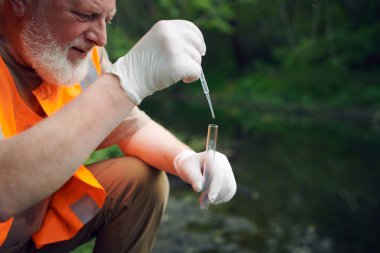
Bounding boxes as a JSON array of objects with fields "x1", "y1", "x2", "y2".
[{"x1": 21, "y1": 0, "x2": 115, "y2": 85}]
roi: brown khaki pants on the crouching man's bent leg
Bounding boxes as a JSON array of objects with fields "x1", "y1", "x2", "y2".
[{"x1": 7, "y1": 157, "x2": 169, "y2": 253}]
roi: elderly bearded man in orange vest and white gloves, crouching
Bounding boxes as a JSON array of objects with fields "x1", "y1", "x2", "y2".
[{"x1": 0, "y1": 0, "x2": 236, "y2": 253}]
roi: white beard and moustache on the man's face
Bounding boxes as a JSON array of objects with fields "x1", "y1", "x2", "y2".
[{"x1": 21, "y1": 8, "x2": 90, "y2": 85}]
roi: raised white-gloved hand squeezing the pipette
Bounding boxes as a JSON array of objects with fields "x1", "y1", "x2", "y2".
[{"x1": 106, "y1": 20, "x2": 206, "y2": 104}]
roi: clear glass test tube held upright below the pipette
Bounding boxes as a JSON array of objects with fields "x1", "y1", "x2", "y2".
[{"x1": 200, "y1": 124, "x2": 218, "y2": 209}]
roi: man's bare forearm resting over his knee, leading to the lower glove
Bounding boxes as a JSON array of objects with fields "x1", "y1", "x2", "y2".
[{"x1": 119, "y1": 120, "x2": 190, "y2": 175}]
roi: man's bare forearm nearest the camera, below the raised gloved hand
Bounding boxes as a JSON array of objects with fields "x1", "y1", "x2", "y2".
[{"x1": 0, "y1": 75, "x2": 134, "y2": 221}]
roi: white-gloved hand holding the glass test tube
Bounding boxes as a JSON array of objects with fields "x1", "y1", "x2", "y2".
[{"x1": 174, "y1": 150, "x2": 236, "y2": 204}]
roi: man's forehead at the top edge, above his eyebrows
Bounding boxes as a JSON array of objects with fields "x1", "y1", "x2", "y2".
[{"x1": 67, "y1": 0, "x2": 116, "y2": 15}]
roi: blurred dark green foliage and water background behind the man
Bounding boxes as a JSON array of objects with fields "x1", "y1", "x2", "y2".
[{"x1": 72, "y1": 0, "x2": 380, "y2": 253}]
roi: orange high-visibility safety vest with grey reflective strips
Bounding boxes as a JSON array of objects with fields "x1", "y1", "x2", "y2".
[{"x1": 0, "y1": 48, "x2": 106, "y2": 248}]
